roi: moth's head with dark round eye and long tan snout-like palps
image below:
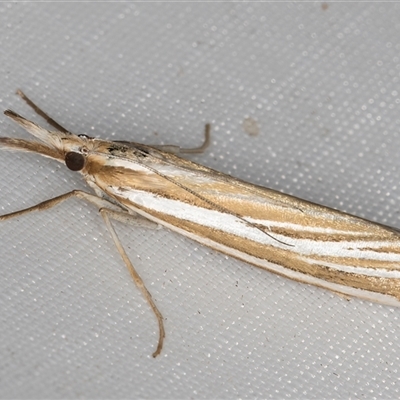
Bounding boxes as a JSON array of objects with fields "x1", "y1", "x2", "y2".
[{"x1": 0, "y1": 110, "x2": 102, "y2": 171}]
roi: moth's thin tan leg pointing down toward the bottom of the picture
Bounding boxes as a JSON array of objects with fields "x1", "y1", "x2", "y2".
[{"x1": 100, "y1": 208, "x2": 165, "y2": 357}]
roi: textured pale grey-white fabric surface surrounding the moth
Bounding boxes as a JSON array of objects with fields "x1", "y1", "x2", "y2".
[{"x1": 0, "y1": 2, "x2": 400, "y2": 399}]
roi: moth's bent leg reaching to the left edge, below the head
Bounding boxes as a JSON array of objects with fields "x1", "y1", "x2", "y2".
[{"x1": 0, "y1": 190, "x2": 121, "y2": 221}]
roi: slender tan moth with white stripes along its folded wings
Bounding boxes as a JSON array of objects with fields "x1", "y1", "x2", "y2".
[{"x1": 0, "y1": 90, "x2": 400, "y2": 357}]
